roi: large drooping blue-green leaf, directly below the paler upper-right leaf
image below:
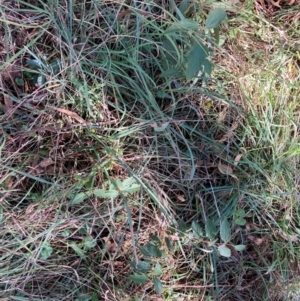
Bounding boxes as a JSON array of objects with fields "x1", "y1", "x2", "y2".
[{"x1": 186, "y1": 43, "x2": 207, "y2": 79}]
